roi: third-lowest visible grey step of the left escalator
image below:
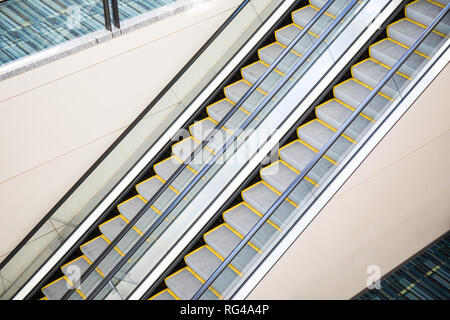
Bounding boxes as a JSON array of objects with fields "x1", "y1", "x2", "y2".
[{"x1": 80, "y1": 235, "x2": 122, "y2": 275}]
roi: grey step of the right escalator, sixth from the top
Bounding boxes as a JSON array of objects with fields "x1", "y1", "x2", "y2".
[{"x1": 316, "y1": 99, "x2": 374, "y2": 141}]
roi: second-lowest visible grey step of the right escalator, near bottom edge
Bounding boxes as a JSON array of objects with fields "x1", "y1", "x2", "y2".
[{"x1": 164, "y1": 267, "x2": 220, "y2": 300}]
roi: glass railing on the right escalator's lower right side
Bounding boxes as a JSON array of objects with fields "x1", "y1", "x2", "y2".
[{"x1": 193, "y1": 4, "x2": 450, "y2": 299}]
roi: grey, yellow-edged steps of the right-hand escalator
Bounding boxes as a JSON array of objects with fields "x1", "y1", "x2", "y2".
[{"x1": 150, "y1": 0, "x2": 450, "y2": 300}]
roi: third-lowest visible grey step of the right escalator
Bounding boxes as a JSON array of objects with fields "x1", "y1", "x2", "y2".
[{"x1": 184, "y1": 246, "x2": 239, "y2": 295}]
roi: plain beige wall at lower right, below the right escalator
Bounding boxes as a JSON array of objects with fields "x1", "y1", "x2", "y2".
[{"x1": 248, "y1": 65, "x2": 450, "y2": 299}]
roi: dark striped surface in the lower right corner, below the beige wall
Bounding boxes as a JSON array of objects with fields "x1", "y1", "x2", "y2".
[{"x1": 355, "y1": 232, "x2": 450, "y2": 300}]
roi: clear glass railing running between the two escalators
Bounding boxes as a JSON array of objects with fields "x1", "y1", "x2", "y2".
[{"x1": 69, "y1": 0, "x2": 376, "y2": 299}]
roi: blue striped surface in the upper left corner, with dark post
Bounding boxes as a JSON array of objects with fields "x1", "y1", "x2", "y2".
[{"x1": 0, "y1": 0, "x2": 176, "y2": 65}]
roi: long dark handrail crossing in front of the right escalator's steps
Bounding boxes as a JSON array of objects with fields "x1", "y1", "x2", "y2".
[{"x1": 192, "y1": 4, "x2": 450, "y2": 300}]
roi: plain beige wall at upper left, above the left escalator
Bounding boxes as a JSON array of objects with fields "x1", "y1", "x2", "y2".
[{"x1": 0, "y1": 0, "x2": 241, "y2": 261}]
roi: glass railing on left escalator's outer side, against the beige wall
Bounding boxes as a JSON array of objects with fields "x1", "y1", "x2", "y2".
[{"x1": 0, "y1": 0, "x2": 288, "y2": 299}]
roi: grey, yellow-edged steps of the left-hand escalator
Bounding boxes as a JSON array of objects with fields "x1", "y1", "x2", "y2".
[{"x1": 36, "y1": 0, "x2": 376, "y2": 299}]
